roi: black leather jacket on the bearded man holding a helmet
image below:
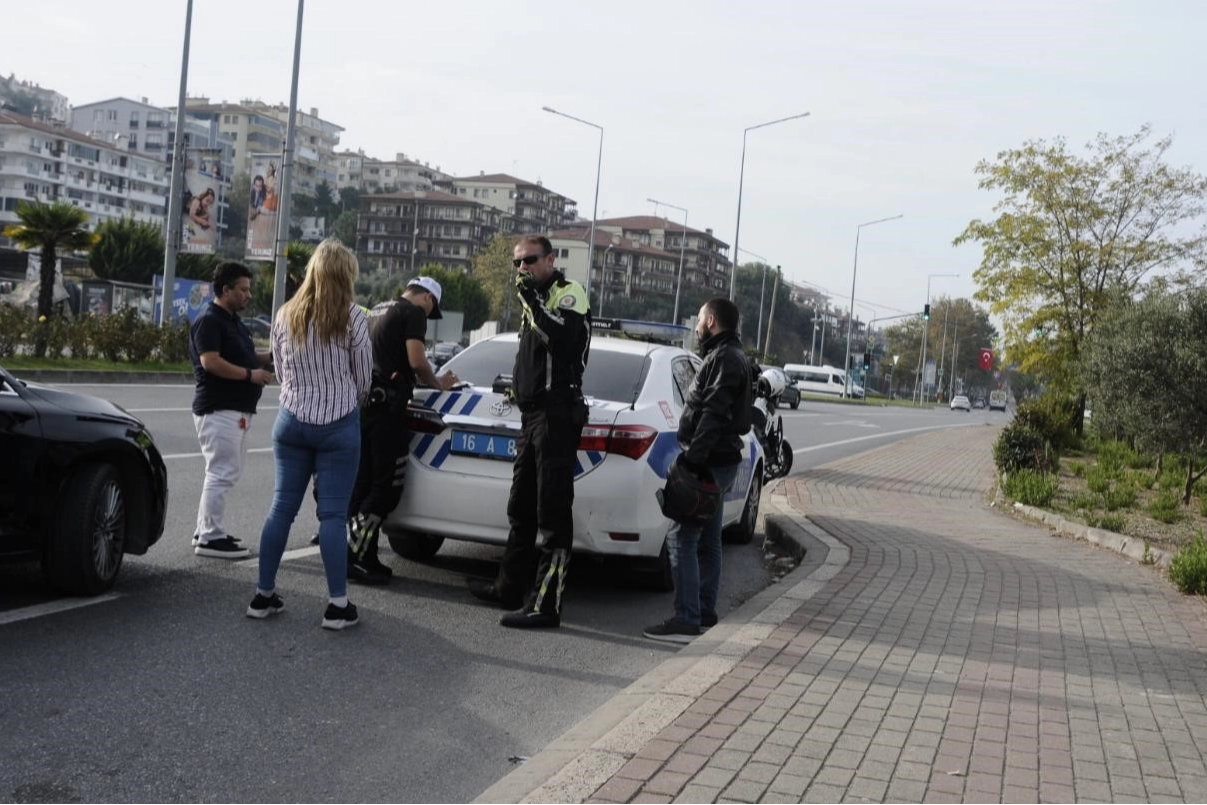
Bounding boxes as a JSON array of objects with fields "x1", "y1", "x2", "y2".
[{"x1": 678, "y1": 331, "x2": 751, "y2": 467}]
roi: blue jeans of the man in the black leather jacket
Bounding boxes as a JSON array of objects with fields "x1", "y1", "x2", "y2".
[{"x1": 666, "y1": 463, "x2": 739, "y2": 626}]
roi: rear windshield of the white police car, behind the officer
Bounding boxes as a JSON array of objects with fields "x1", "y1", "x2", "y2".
[{"x1": 443, "y1": 342, "x2": 649, "y2": 402}]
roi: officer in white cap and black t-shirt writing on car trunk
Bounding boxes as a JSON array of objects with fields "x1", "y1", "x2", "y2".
[{"x1": 348, "y1": 276, "x2": 459, "y2": 584}]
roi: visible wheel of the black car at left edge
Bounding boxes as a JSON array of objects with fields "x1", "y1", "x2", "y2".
[{"x1": 42, "y1": 463, "x2": 127, "y2": 595}]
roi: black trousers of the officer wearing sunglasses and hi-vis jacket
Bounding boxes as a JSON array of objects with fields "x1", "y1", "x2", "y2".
[{"x1": 495, "y1": 401, "x2": 587, "y2": 613}]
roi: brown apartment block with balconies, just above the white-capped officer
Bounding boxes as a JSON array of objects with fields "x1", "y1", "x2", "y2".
[{"x1": 356, "y1": 191, "x2": 501, "y2": 272}]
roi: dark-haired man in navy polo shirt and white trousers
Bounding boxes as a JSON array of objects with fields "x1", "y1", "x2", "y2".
[{"x1": 188, "y1": 261, "x2": 273, "y2": 559}]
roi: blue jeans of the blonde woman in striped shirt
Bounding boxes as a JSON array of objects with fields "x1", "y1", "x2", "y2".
[{"x1": 260, "y1": 408, "x2": 361, "y2": 597}]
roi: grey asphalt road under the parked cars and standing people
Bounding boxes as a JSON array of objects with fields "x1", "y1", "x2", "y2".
[{"x1": 0, "y1": 386, "x2": 1004, "y2": 803}]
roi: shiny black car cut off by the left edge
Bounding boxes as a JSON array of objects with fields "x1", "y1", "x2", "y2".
[{"x1": 0, "y1": 369, "x2": 168, "y2": 595}]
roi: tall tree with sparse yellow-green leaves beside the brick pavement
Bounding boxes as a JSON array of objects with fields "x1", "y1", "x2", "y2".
[{"x1": 955, "y1": 126, "x2": 1207, "y2": 422}]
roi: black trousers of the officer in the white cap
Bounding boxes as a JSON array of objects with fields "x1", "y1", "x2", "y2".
[{"x1": 348, "y1": 403, "x2": 410, "y2": 528}]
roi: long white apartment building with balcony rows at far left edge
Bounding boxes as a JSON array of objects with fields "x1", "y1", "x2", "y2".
[{"x1": 0, "y1": 111, "x2": 169, "y2": 228}]
